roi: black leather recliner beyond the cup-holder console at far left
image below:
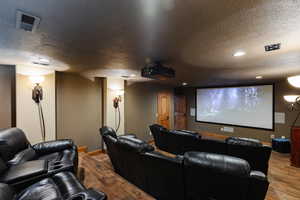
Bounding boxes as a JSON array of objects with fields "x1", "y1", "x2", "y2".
[{"x1": 0, "y1": 128, "x2": 78, "y2": 172}]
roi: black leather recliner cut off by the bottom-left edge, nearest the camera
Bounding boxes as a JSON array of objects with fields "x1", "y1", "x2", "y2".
[{"x1": 0, "y1": 172, "x2": 106, "y2": 200}]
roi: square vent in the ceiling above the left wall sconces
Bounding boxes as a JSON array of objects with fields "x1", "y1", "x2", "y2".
[{"x1": 16, "y1": 10, "x2": 40, "y2": 32}]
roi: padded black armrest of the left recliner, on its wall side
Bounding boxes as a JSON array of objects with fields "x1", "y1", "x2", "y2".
[{"x1": 32, "y1": 139, "x2": 76, "y2": 155}]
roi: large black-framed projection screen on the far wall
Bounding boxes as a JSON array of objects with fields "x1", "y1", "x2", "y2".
[{"x1": 196, "y1": 85, "x2": 274, "y2": 130}]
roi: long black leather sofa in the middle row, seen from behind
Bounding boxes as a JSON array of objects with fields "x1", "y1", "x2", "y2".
[{"x1": 100, "y1": 127, "x2": 269, "y2": 200}]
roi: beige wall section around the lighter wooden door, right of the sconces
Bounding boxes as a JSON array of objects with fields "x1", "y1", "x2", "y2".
[{"x1": 125, "y1": 82, "x2": 174, "y2": 141}]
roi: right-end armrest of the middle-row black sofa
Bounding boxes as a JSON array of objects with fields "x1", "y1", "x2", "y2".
[{"x1": 248, "y1": 171, "x2": 269, "y2": 200}]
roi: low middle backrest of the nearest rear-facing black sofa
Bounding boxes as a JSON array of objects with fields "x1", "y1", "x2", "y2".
[{"x1": 143, "y1": 152, "x2": 184, "y2": 200}]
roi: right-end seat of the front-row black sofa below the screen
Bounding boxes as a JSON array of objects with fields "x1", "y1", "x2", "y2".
[{"x1": 226, "y1": 137, "x2": 272, "y2": 175}]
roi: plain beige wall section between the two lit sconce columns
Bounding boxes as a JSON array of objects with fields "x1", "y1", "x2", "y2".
[{"x1": 56, "y1": 72, "x2": 102, "y2": 151}]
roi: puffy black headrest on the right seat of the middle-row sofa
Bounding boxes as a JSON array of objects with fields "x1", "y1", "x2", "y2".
[{"x1": 184, "y1": 151, "x2": 250, "y2": 177}]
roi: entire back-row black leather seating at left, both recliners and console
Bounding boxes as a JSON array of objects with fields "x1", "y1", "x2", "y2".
[{"x1": 0, "y1": 128, "x2": 107, "y2": 200}]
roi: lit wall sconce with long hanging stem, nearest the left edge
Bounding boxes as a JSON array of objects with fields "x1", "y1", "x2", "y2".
[{"x1": 29, "y1": 76, "x2": 46, "y2": 141}]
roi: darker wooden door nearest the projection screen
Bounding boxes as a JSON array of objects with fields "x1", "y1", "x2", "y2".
[{"x1": 174, "y1": 95, "x2": 187, "y2": 129}]
